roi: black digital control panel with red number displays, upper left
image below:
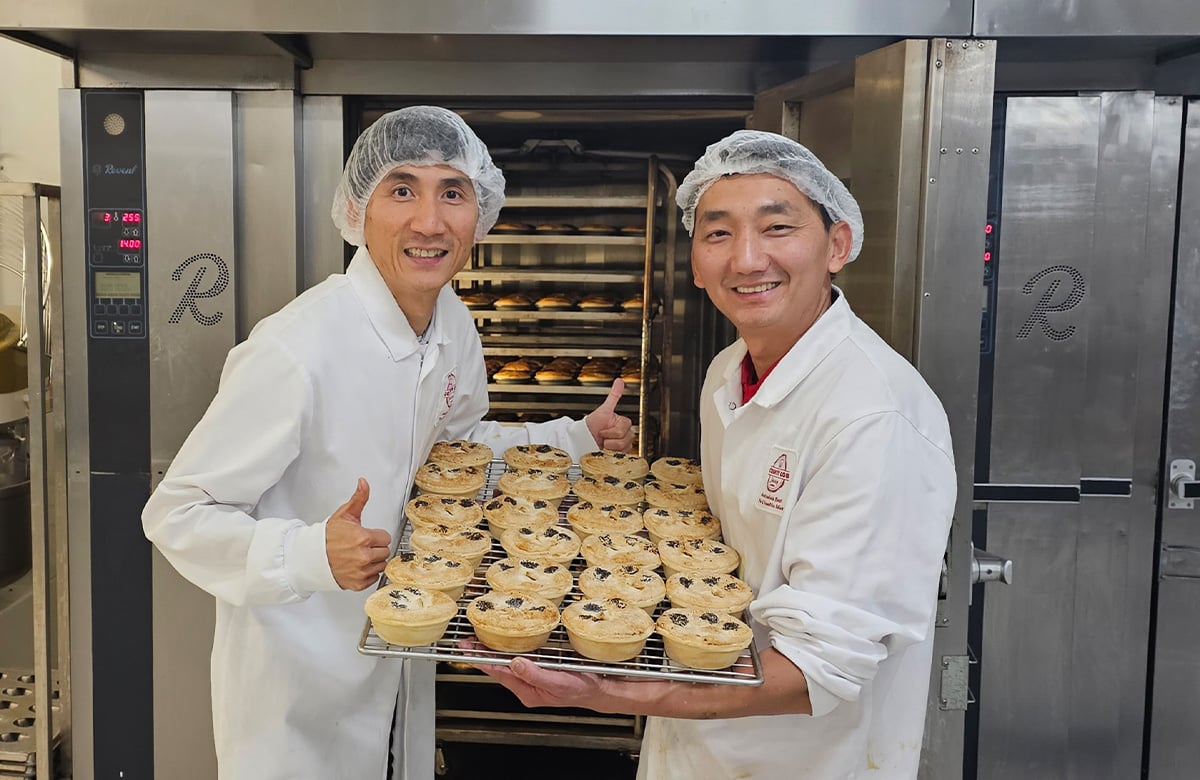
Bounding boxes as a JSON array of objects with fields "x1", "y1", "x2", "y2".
[{"x1": 84, "y1": 88, "x2": 146, "y2": 338}]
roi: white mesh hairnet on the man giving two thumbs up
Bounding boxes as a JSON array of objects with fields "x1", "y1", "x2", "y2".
[{"x1": 332, "y1": 106, "x2": 504, "y2": 246}]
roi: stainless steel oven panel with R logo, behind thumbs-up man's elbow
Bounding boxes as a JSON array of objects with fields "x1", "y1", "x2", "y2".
[{"x1": 145, "y1": 91, "x2": 234, "y2": 779}]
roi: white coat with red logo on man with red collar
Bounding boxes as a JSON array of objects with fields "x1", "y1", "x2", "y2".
[{"x1": 638, "y1": 293, "x2": 955, "y2": 780}]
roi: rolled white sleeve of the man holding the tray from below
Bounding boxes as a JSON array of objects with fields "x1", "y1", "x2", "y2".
[{"x1": 750, "y1": 412, "x2": 956, "y2": 715}]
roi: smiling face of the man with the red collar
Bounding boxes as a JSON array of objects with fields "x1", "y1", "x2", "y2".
[{"x1": 691, "y1": 174, "x2": 852, "y2": 360}]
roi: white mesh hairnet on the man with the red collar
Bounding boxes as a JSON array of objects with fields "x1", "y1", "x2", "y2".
[{"x1": 676, "y1": 130, "x2": 863, "y2": 263}]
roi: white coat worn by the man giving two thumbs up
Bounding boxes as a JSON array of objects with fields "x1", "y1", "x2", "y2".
[{"x1": 143, "y1": 248, "x2": 595, "y2": 780}]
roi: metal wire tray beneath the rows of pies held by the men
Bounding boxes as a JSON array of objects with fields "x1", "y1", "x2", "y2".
[{"x1": 359, "y1": 461, "x2": 762, "y2": 686}]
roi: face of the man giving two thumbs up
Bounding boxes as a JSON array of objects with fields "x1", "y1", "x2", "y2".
[{"x1": 362, "y1": 166, "x2": 479, "y2": 332}]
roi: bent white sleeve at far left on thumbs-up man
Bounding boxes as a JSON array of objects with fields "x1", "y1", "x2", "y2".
[{"x1": 142, "y1": 336, "x2": 338, "y2": 605}]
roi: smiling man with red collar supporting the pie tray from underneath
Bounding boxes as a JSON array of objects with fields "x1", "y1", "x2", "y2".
[{"x1": 482, "y1": 131, "x2": 955, "y2": 780}]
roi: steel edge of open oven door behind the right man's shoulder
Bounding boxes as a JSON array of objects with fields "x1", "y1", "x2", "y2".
[{"x1": 912, "y1": 38, "x2": 1006, "y2": 779}]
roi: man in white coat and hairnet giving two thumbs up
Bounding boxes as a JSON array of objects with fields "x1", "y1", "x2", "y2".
[{"x1": 143, "y1": 107, "x2": 632, "y2": 780}]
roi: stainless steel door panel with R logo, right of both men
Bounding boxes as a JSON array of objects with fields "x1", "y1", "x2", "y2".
[{"x1": 977, "y1": 97, "x2": 1100, "y2": 484}]
